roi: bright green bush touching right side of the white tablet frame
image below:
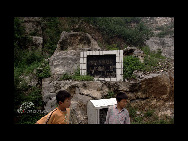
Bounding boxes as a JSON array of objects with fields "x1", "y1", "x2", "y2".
[{"x1": 123, "y1": 56, "x2": 143, "y2": 80}]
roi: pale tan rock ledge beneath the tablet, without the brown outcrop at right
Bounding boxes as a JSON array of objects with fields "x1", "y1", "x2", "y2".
[{"x1": 42, "y1": 78, "x2": 128, "y2": 124}]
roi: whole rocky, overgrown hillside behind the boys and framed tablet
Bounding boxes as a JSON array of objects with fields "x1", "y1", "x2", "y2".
[{"x1": 14, "y1": 17, "x2": 174, "y2": 123}]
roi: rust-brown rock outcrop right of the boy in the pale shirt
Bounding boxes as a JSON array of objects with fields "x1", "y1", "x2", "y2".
[{"x1": 128, "y1": 73, "x2": 174, "y2": 118}]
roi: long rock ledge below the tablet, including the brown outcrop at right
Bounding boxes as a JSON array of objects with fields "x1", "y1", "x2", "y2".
[{"x1": 42, "y1": 74, "x2": 174, "y2": 124}]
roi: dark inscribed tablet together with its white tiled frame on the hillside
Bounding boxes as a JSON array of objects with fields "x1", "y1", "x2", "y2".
[{"x1": 80, "y1": 50, "x2": 123, "y2": 81}]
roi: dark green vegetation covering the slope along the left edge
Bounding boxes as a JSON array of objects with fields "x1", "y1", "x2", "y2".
[{"x1": 14, "y1": 17, "x2": 56, "y2": 124}]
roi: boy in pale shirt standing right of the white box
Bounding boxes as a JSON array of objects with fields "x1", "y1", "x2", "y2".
[{"x1": 105, "y1": 92, "x2": 130, "y2": 124}]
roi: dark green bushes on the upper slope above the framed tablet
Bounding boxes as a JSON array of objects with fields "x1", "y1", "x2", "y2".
[{"x1": 83, "y1": 17, "x2": 153, "y2": 46}]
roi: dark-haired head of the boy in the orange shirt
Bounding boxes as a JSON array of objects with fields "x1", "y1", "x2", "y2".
[{"x1": 56, "y1": 90, "x2": 71, "y2": 108}]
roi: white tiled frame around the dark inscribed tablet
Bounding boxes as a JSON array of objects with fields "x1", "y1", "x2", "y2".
[{"x1": 80, "y1": 50, "x2": 123, "y2": 81}]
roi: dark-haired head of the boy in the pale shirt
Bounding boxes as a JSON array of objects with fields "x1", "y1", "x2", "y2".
[{"x1": 116, "y1": 92, "x2": 128, "y2": 108}]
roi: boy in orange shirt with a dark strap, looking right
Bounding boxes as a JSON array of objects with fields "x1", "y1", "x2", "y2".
[{"x1": 36, "y1": 90, "x2": 71, "y2": 124}]
